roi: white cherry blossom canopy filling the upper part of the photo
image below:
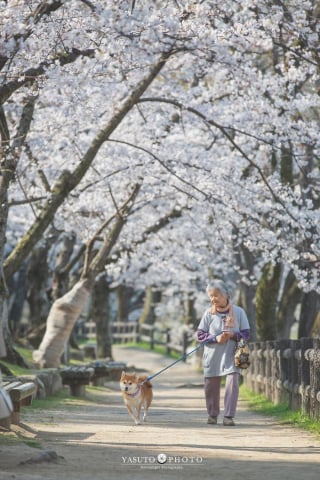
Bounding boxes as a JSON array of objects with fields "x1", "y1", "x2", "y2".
[{"x1": 0, "y1": 0, "x2": 320, "y2": 360}]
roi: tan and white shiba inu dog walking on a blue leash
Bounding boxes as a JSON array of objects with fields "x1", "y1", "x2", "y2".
[{"x1": 120, "y1": 372, "x2": 153, "y2": 425}]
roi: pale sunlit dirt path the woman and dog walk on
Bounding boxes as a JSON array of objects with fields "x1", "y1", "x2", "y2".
[{"x1": 0, "y1": 348, "x2": 320, "y2": 480}]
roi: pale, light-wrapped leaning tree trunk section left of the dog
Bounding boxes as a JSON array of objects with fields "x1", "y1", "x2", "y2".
[{"x1": 33, "y1": 279, "x2": 91, "y2": 368}]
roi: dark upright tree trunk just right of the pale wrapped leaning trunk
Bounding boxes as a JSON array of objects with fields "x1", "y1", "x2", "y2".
[{"x1": 91, "y1": 275, "x2": 112, "y2": 359}]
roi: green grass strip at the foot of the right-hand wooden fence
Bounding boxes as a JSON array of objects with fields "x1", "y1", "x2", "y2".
[{"x1": 240, "y1": 385, "x2": 320, "y2": 435}]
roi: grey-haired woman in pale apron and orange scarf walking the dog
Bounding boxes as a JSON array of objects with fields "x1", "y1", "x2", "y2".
[{"x1": 197, "y1": 280, "x2": 250, "y2": 426}]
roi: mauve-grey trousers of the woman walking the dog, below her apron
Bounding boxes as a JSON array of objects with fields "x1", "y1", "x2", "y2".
[{"x1": 204, "y1": 373, "x2": 239, "y2": 417}]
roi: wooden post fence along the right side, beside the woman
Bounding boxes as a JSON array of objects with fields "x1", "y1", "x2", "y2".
[{"x1": 243, "y1": 338, "x2": 320, "y2": 420}]
